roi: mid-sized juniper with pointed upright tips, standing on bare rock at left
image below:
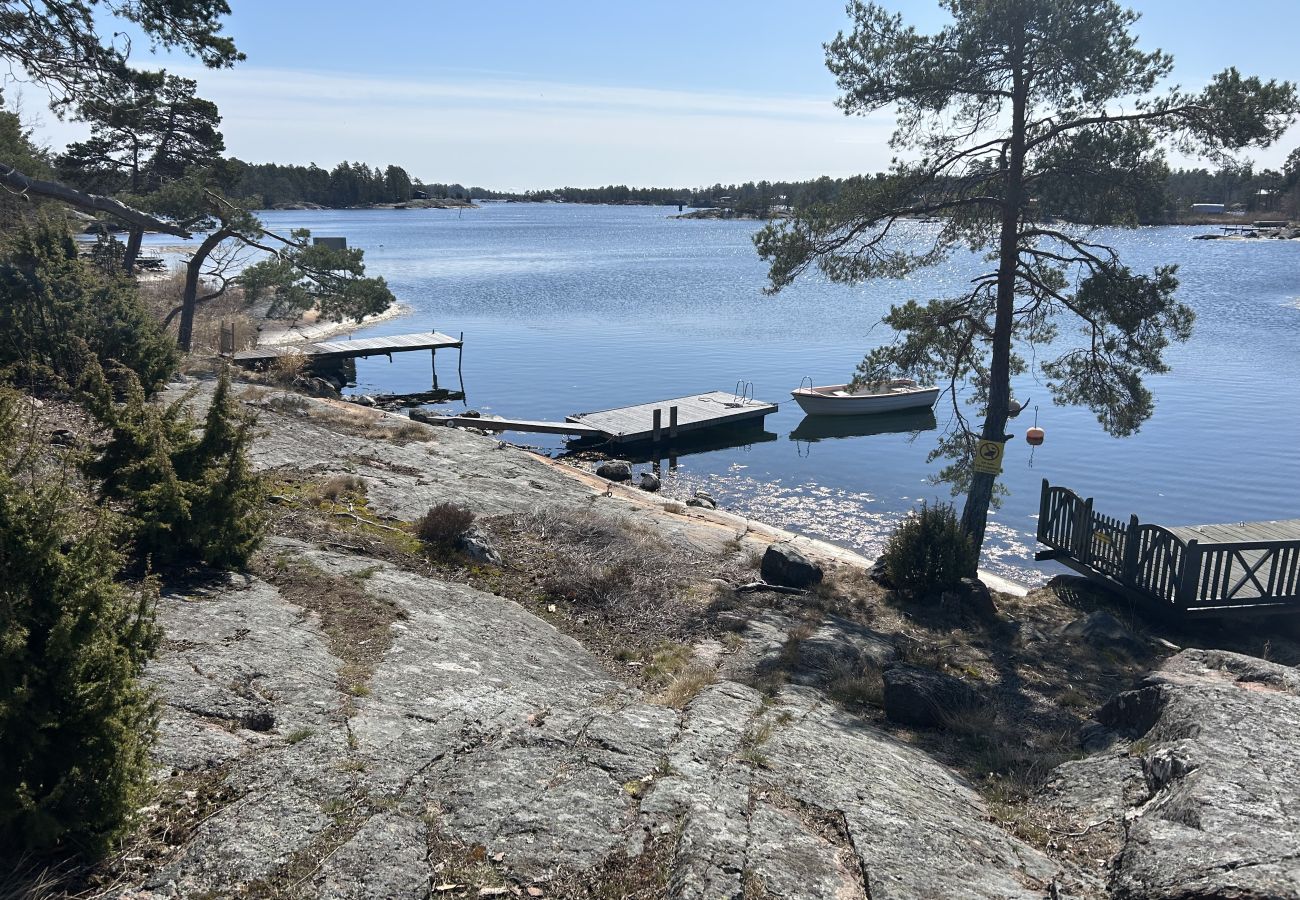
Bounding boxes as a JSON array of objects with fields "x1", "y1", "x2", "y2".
[{"x1": 87, "y1": 371, "x2": 267, "y2": 568}]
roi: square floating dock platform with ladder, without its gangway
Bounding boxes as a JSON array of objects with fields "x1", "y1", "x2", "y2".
[{"x1": 566, "y1": 390, "x2": 777, "y2": 443}]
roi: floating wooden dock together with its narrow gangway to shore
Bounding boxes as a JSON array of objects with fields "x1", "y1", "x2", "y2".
[{"x1": 426, "y1": 390, "x2": 777, "y2": 443}]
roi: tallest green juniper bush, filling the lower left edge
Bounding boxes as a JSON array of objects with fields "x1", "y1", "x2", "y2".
[{"x1": 0, "y1": 389, "x2": 157, "y2": 860}]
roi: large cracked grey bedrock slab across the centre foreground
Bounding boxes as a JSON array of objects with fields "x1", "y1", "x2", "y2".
[{"x1": 122, "y1": 540, "x2": 1058, "y2": 900}]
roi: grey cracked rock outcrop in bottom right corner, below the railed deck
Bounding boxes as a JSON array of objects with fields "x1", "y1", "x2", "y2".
[{"x1": 1102, "y1": 650, "x2": 1300, "y2": 900}]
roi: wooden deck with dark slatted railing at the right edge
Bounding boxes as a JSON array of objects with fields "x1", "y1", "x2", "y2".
[{"x1": 1036, "y1": 480, "x2": 1300, "y2": 616}]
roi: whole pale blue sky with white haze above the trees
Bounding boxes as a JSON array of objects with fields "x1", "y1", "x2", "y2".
[{"x1": 17, "y1": 0, "x2": 1300, "y2": 190}]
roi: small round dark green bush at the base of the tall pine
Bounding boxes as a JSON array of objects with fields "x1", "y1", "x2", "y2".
[{"x1": 880, "y1": 503, "x2": 979, "y2": 597}]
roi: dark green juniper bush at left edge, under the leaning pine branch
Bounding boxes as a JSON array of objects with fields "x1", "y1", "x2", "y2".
[{"x1": 0, "y1": 221, "x2": 179, "y2": 394}]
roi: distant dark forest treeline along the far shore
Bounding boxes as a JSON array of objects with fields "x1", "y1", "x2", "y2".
[{"x1": 228, "y1": 153, "x2": 1300, "y2": 224}]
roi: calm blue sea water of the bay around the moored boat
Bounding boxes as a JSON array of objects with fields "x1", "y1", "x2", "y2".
[{"x1": 236, "y1": 204, "x2": 1300, "y2": 581}]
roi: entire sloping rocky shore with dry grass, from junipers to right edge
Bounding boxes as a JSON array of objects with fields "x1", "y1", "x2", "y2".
[{"x1": 61, "y1": 381, "x2": 1300, "y2": 900}]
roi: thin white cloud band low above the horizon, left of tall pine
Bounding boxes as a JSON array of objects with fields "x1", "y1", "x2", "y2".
[{"x1": 165, "y1": 66, "x2": 892, "y2": 190}]
